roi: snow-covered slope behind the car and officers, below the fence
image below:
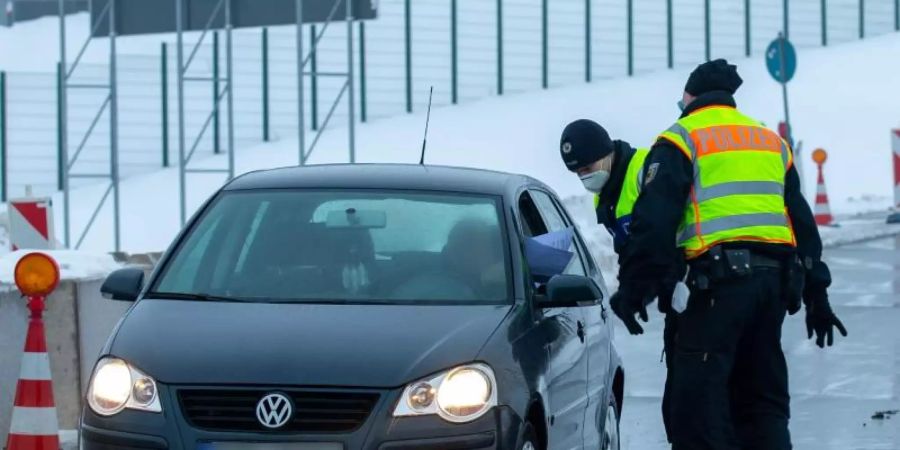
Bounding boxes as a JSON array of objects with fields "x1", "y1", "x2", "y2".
[{"x1": 44, "y1": 34, "x2": 900, "y2": 252}]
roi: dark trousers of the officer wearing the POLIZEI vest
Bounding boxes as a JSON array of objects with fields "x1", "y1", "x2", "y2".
[{"x1": 664, "y1": 268, "x2": 791, "y2": 450}]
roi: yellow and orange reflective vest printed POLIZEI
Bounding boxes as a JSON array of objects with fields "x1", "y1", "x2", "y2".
[{"x1": 660, "y1": 106, "x2": 796, "y2": 259}]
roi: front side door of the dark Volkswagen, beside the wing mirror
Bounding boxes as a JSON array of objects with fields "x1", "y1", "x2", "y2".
[{"x1": 519, "y1": 191, "x2": 588, "y2": 449}]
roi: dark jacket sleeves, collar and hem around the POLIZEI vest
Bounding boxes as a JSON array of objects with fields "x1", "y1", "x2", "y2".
[{"x1": 619, "y1": 92, "x2": 831, "y2": 288}]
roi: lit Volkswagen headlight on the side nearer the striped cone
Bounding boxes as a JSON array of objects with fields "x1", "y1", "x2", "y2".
[{"x1": 87, "y1": 357, "x2": 162, "y2": 416}]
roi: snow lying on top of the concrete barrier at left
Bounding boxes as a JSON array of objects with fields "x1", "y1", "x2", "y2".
[{"x1": 0, "y1": 250, "x2": 121, "y2": 286}]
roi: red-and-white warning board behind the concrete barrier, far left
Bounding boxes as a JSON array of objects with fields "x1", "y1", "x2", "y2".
[{"x1": 9, "y1": 198, "x2": 54, "y2": 251}]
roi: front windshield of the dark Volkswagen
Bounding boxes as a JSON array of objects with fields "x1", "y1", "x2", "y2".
[{"x1": 147, "y1": 190, "x2": 510, "y2": 303}]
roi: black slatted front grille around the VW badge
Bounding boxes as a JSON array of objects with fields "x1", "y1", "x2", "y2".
[{"x1": 178, "y1": 389, "x2": 379, "y2": 433}]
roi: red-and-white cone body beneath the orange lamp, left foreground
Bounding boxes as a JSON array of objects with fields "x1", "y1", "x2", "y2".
[{"x1": 6, "y1": 297, "x2": 59, "y2": 450}]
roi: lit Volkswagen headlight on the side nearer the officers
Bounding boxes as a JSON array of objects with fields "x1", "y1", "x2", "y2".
[{"x1": 394, "y1": 364, "x2": 497, "y2": 423}]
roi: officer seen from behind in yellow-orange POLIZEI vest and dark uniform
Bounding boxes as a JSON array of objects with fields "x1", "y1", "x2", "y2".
[{"x1": 611, "y1": 59, "x2": 847, "y2": 450}]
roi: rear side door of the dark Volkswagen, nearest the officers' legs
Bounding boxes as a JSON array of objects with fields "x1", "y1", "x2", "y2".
[{"x1": 535, "y1": 189, "x2": 612, "y2": 448}]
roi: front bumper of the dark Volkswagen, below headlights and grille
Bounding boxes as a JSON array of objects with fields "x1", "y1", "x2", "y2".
[{"x1": 81, "y1": 386, "x2": 522, "y2": 450}]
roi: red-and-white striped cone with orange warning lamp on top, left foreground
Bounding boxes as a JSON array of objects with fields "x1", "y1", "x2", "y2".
[{"x1": 6, "y1": 253, "x2": 59, "y2": 450}]
